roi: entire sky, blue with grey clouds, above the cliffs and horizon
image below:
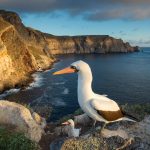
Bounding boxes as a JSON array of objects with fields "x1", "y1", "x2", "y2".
[{"x1": 0, "y1": 0, "x2": 150, "y2": 47}]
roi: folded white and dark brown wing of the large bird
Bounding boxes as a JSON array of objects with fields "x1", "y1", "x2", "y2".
[{"x1": 90, "y1": 99, "x2": 123, "y2": 121}]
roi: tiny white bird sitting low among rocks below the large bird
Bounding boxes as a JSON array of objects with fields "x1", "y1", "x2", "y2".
[{"x1": 62, "y1": 119, "x2": 81, "y2": 137}]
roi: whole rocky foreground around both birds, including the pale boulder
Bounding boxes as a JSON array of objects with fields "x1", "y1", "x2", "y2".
[{"x1": 0, "y1": 100, "x2": 150, "y2": 150}]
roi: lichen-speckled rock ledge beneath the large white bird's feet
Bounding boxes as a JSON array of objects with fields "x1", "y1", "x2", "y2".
[{"x1": 61, "y1": 116, "x2": 150, "y2": 150}]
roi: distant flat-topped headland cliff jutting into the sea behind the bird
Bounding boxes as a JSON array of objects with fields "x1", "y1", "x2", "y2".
[{"x1": 46, "y1": 35, "x2": 138, "y2": 54}]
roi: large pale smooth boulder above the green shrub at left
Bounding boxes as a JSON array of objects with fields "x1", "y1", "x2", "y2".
[{"x1": 0, "y1": 100, "x2": 46, "y2": 142}]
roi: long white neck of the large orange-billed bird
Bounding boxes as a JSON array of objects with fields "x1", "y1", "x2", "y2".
[{"x1": 78, "y1": 70, "x2": 93, "y2": 101}]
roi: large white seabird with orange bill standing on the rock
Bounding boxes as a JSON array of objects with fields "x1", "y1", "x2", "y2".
[{"x1": 53, "y1": 60, "x2": 136, "y2": 129}]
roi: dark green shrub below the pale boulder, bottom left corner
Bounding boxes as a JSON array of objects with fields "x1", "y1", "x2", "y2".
[{"x1": 0, "y1": 127, "x2": 40, "y2": 150}]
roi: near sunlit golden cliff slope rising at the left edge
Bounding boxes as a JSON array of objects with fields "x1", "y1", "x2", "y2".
[{"x1": 0, "y1": 11, "x2": 53, "y2": 91}]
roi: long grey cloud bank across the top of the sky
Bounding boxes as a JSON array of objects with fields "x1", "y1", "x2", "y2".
[{"x1": 0, "y1": 0, "x2": 150, "y2": 21}]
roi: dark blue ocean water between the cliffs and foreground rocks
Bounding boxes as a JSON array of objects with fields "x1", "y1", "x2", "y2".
[{"x1": 0, "y1": 48, "x2": 150, "y2": 121}]
